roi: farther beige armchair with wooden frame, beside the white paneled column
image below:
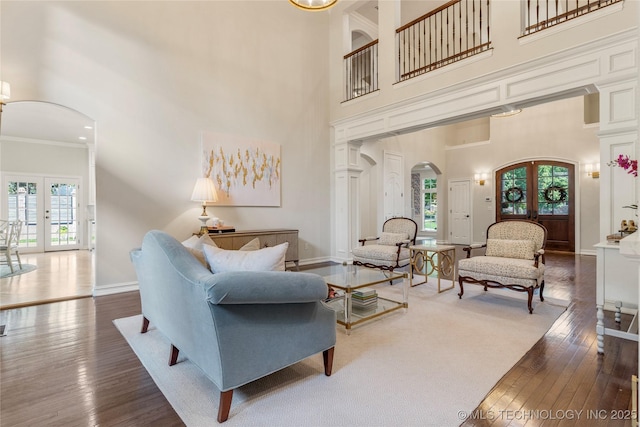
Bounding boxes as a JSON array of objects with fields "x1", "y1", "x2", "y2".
[{"x1": 352, "y1": 218, "x2": 418, "y2": 271}]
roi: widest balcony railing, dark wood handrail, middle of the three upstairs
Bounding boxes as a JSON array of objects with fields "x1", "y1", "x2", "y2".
[{"x1": 396, "y1": 0, "x2": 491, "y2": 81}]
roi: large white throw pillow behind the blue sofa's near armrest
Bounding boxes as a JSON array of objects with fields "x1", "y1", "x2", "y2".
[{"x1": 204, "y1": 242, "x2": 289, "y2": 273}]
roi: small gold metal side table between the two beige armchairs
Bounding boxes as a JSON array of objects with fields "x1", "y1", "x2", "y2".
[{"x1": 409, "y1": 244, "x2": 456, "y2": 293}]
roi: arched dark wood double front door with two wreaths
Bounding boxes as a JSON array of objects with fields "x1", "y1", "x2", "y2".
[{"x1": 496, "y1": 160, "x2": 575, "y2": 252}]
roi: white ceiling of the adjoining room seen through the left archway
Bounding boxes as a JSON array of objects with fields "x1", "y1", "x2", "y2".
[{"x1": 0, "y1": 101, "x2": 95, "y2": 145}]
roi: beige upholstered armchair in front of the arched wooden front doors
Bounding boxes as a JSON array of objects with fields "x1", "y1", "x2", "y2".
[{"x1": 458, "y1": 221, "x2": 547, "y2": 313}]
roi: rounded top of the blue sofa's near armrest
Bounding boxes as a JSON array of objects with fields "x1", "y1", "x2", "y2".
[{"x1": 205, "y1": 271, "x2": 329, "y2": 304}]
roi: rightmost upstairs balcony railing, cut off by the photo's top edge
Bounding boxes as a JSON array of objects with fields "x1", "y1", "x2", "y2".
[{"x1": 523, "y1": 0, "x2": 623, "y2": 35}]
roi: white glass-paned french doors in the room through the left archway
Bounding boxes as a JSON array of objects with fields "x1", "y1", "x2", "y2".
[{"x1": 2, "y1": 176, "x2": 81, "y2": 252}]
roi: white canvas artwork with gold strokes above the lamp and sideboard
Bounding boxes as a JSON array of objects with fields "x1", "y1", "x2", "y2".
[{"x1": 202, "y1": 132, "x2": 282, "y2": 206}]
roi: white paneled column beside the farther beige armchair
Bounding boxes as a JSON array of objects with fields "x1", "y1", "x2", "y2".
[{"x1": 334, "y1": 141, "x2": 362, "y2": 261}]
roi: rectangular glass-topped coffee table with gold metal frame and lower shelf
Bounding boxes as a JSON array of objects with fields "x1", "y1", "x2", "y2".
[{"x1": 304, "y1": 264, "x2": 409, "y2": 335}]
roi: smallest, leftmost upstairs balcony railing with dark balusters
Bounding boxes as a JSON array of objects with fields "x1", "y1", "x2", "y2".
[{"x1": 344, "y1": 40, "x2": 378, "y2": 101}]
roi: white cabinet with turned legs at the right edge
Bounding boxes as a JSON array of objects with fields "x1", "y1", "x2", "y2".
[{"x1": 596, "y1": 242, "x2": 638, "y2": 353}]
